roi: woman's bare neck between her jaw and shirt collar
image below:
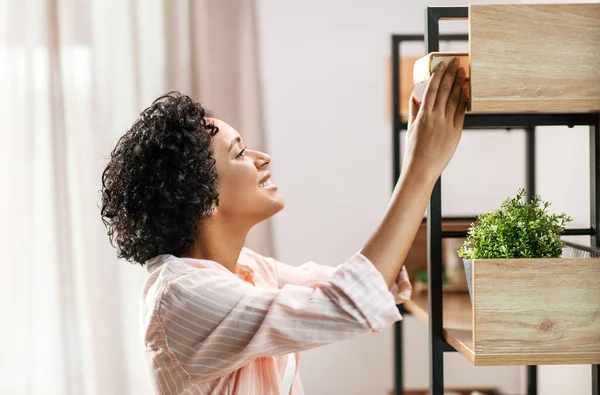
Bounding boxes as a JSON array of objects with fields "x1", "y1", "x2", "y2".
[{"x1": 182, "y1": 216, "x2": 251, "y2": 273}]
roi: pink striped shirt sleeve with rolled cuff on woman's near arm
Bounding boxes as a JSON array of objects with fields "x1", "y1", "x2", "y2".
[{"x1": 158, "y1": 254, "x2": 402, "y2": 380}]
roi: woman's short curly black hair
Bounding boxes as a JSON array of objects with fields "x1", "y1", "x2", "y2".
[{"x1": 100, "y1": 92, "x2": 219, "y2": 265}]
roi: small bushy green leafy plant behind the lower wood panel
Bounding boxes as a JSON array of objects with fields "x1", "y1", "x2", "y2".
[{"x1": 458, "y1": 189, "x2": 572, "y2": 259}]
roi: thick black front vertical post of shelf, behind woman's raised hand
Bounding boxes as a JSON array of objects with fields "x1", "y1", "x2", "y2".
[{"x1": 425, "y1": 7, "x2": 444, "y2": 395}]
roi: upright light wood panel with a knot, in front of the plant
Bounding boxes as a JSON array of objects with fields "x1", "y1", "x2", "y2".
[{"x1": 473, "y1": 258, "x2": 600, "y2": 363}]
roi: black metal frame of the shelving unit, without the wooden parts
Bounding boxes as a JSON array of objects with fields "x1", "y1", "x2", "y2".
[{"x1": 391, "y1": 6, "x2": 600, "y2": 395}]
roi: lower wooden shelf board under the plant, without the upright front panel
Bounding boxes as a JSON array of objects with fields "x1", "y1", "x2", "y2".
[{"x1": 404, "y1": 292, "x2": 598, "y2": 366}]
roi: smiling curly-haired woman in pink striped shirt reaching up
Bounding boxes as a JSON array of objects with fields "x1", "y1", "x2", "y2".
[{"x1": 102, "y1": 56, "x2": 466, "y2": 395}]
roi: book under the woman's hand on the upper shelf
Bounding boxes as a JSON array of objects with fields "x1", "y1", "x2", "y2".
[{"x1": 413, "y1": 52, "x2": 471, "y2": 103}]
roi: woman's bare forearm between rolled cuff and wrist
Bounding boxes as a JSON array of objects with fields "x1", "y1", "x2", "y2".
[{"x1": 361, "y1": 163, "x2": 437, "y2": 287}]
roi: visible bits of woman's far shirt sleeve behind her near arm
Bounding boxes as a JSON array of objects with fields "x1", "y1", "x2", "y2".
[{"x1": 263, "y1": 252, "x2": 412, "y2": 304}]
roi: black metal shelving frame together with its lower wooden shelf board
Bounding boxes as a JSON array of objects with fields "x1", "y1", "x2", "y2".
[{"x1": 391, "y1": 7, "x2": 600, "y2": 395}]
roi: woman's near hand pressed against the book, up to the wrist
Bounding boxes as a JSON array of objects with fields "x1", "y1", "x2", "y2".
[{"x1": 404, "y1": 58, "x2": 467, "y2": 183}]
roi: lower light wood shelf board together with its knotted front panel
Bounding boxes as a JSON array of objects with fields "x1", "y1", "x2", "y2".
[{"x1": 404, "y1": 258, "x2": 600, "y2": 366}]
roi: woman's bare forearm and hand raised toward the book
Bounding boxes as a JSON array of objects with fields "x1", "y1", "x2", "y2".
[{"x1": 361, "y1": 57, "x2": 466, "y2": 286}]
